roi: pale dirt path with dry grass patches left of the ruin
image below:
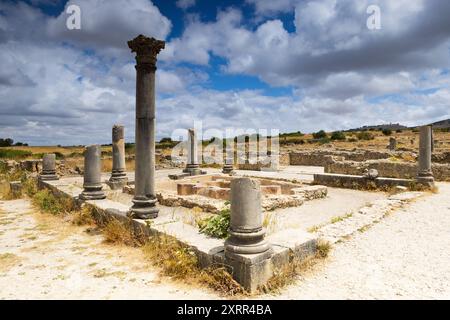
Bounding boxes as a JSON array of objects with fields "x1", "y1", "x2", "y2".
[{"x1": 0, "y1": 200, "x2": 215, "y2": 300}]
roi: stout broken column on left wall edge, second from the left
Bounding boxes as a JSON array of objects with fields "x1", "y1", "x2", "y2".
[{"x1": 79, "y1": 145, "x2": 106, "y2": 200}]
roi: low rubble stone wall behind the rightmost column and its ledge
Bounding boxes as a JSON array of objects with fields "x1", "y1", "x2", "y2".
[{"x1": 325, "y1": 160, "x2": 450, "y2": 181}]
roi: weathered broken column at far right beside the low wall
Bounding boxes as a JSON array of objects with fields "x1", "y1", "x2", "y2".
[{"x1": 417, "y1": 126, "x2": 434, "y2": 187}]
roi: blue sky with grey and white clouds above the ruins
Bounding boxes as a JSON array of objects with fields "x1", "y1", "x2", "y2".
[{"x1": 0, "y1": 0, "x2": 450, "y2": 145}]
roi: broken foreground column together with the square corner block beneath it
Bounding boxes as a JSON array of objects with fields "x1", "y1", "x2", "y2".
[{"x1": 225, "y1": 178, "x2": 273, "y2": 292}]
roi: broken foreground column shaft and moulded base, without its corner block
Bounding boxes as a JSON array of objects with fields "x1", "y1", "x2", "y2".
[{"x1": 225, "y1": 178, "x2": 270, "y2": 255}]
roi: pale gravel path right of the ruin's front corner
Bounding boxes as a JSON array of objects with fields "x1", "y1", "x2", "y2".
[{"x1": 270, "y1": 183, "x2": 450, "y2": 299}]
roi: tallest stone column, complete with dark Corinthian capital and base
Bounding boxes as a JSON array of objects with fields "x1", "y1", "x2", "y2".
[{"x1": 128, "y1": 35, "x2": 165, "y2": 219}]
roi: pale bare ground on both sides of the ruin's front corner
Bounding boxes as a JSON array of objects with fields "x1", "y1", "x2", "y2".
[{"x1": 0, "y1": 183, "x2": 450, "y2": 299}]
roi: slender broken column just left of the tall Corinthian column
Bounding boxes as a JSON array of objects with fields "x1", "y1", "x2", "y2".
[{"x1": 109, "y1": 124, "x2": 128, "y2": 189}]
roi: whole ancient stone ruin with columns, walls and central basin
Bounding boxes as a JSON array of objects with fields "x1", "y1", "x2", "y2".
[{"x1": 29, "y1": 35, "x2": 450, "y2": 292}]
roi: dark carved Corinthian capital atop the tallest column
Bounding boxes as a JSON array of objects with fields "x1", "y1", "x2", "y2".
[{"x1": 128, "y1": 34, "x2": 166, "y2": 67}]
